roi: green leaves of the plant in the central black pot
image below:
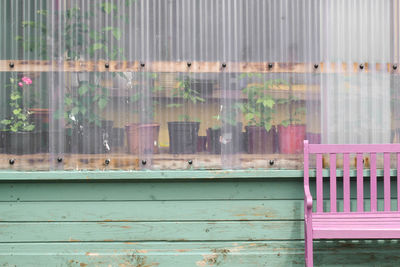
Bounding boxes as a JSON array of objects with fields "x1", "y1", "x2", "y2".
[{"x1": 167, "y1": 76, "x2": 205, "y2": 122}]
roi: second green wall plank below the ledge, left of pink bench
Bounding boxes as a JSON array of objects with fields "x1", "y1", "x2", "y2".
[{"x1": 0, "y1": 200, "x2": 302, "y2": 222}]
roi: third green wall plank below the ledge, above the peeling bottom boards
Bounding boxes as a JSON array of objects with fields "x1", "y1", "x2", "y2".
[{"x1": 0, "y1": 221, "x2": 303, "y2": 243}]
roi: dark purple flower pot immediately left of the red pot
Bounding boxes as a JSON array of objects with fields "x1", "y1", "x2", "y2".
[{"x1": 245, "y1": 126, "x2": 276, "y2": 154}]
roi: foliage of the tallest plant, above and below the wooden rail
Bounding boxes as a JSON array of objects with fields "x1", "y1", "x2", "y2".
[{"x1": 16, "y1": 0, "x2": 128, "y2": 125}]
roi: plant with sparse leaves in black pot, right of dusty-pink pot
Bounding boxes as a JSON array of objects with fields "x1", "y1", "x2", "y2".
[{"x1": 167, "y1": 76, "x2": 205, "y2": 154}]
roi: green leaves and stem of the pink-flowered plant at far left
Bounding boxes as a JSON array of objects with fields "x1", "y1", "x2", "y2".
[{"x1": 0, "y1": 78, "x2": 35, "y2": 132}]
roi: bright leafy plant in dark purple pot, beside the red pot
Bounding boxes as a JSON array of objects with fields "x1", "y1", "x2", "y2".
[{"x1": 238, "y1": 74, "x2": 286, "y2": 154}]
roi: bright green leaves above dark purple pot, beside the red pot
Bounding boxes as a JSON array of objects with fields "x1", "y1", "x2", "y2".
[{"x1": 236, "y1": 76, "x2": 288, "y2": 131}]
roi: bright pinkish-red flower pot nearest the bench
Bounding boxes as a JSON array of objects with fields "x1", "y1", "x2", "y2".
[{"x1": 278, "y1": 125, "x2": 306, "y2": 154}]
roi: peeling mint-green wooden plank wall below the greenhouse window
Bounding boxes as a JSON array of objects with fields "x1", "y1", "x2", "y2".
[{"x1": 0, "y1": 171, "x2": 400, "y2": 267}]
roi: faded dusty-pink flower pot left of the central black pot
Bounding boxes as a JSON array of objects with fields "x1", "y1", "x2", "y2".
[{"x1": 125, "y1": 123, "x2": 160, "y2": 154}]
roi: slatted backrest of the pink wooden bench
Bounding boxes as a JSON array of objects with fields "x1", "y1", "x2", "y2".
[{"x1": 304, "y1": 140, "x2": 400, "y2": 212}]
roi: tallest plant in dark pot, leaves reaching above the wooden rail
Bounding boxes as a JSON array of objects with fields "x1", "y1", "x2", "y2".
[{"x1": 17, "y1": 1, "x2": 131, "y2": 154}]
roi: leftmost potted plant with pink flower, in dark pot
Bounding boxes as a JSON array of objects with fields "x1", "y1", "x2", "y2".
[{"x1": 0, "y1": 77, "x2": 40, "y2": 154}]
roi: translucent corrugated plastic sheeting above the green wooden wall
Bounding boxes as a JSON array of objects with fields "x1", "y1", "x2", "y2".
[{"x1": 0, "y1": 0, "x2": 400, "y2": 170}]
